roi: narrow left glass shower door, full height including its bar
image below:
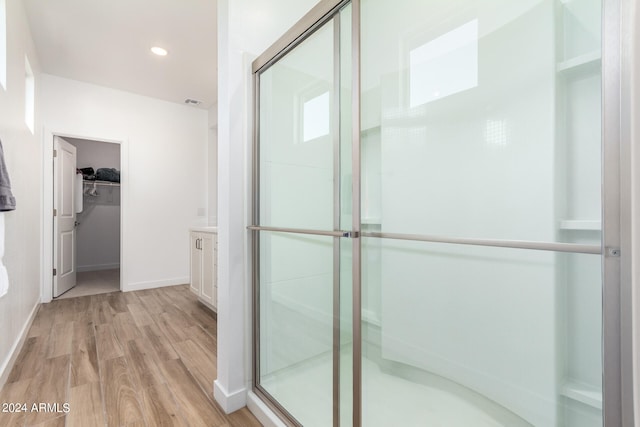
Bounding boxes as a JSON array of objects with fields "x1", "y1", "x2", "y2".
[{"x1": 251, "y1": 5, "x2": 351, "y2": 426}]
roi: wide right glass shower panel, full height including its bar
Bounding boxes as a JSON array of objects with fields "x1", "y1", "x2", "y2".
[{"x1": 360, "y1": 0, "x2": 602, "y2": 427}]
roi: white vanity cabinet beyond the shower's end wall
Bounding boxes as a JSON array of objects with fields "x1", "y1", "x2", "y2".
[{"x1": 189, "y1": 227, "x2": 218, "y2": 311}]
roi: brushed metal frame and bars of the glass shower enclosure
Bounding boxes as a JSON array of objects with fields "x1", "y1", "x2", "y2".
[{"x1": 248, "y1": 0, "x2": 634, "y2": 427}]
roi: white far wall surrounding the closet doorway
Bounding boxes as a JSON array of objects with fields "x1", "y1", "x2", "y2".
[{"x1": 42, "y1": 74, "x2": 207, "y2": 290}]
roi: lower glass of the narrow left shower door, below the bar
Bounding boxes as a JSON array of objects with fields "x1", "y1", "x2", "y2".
[{"x1": 259, "y1": 232, "x2": 333, "y2": 426}]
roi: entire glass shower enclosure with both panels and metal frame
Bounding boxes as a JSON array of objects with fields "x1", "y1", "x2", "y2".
[{"x1": 249, "y1": 0, "x2": 620, "y2": 427}]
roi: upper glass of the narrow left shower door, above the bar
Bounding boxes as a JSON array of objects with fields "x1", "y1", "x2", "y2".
[{"x1": 259, "y1": 21, "x2": 336, "y2": 230}]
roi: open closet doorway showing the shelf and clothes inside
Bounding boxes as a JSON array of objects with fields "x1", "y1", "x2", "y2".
[{"x1": 53, "y1": 137, "x2": 121, "y2": 298}]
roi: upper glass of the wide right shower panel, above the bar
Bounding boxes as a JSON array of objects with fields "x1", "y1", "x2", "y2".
[{"x1": 361, "y1": 0, "x2": 601, "y2": 242}]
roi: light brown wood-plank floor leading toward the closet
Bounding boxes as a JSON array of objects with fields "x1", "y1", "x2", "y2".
[{"x1": 0, "y1": 285, "x2": 260, "y2": 427}]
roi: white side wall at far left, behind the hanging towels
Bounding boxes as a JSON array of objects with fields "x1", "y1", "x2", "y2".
[{"x1": 0, "y1": 0, "x2": 42, "y2": 386}]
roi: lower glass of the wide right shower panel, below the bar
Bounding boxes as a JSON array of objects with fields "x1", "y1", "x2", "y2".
[{"x1": 362, "y1": 238, "x2": 602, "y2": 427}]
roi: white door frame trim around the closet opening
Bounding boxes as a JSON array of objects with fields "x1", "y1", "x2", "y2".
[{"x1": 40, "y1": 128, "x2": 129, "y2": 303}]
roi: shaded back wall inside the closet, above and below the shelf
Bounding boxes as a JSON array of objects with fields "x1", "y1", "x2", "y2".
[{"x1": 64, "y1": 138, "x2": 122, "y2": 272}]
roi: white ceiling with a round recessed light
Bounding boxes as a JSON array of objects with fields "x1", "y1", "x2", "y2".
[{"x1": 24, "y1": 0, "x2": 218, "y2": 108}]
